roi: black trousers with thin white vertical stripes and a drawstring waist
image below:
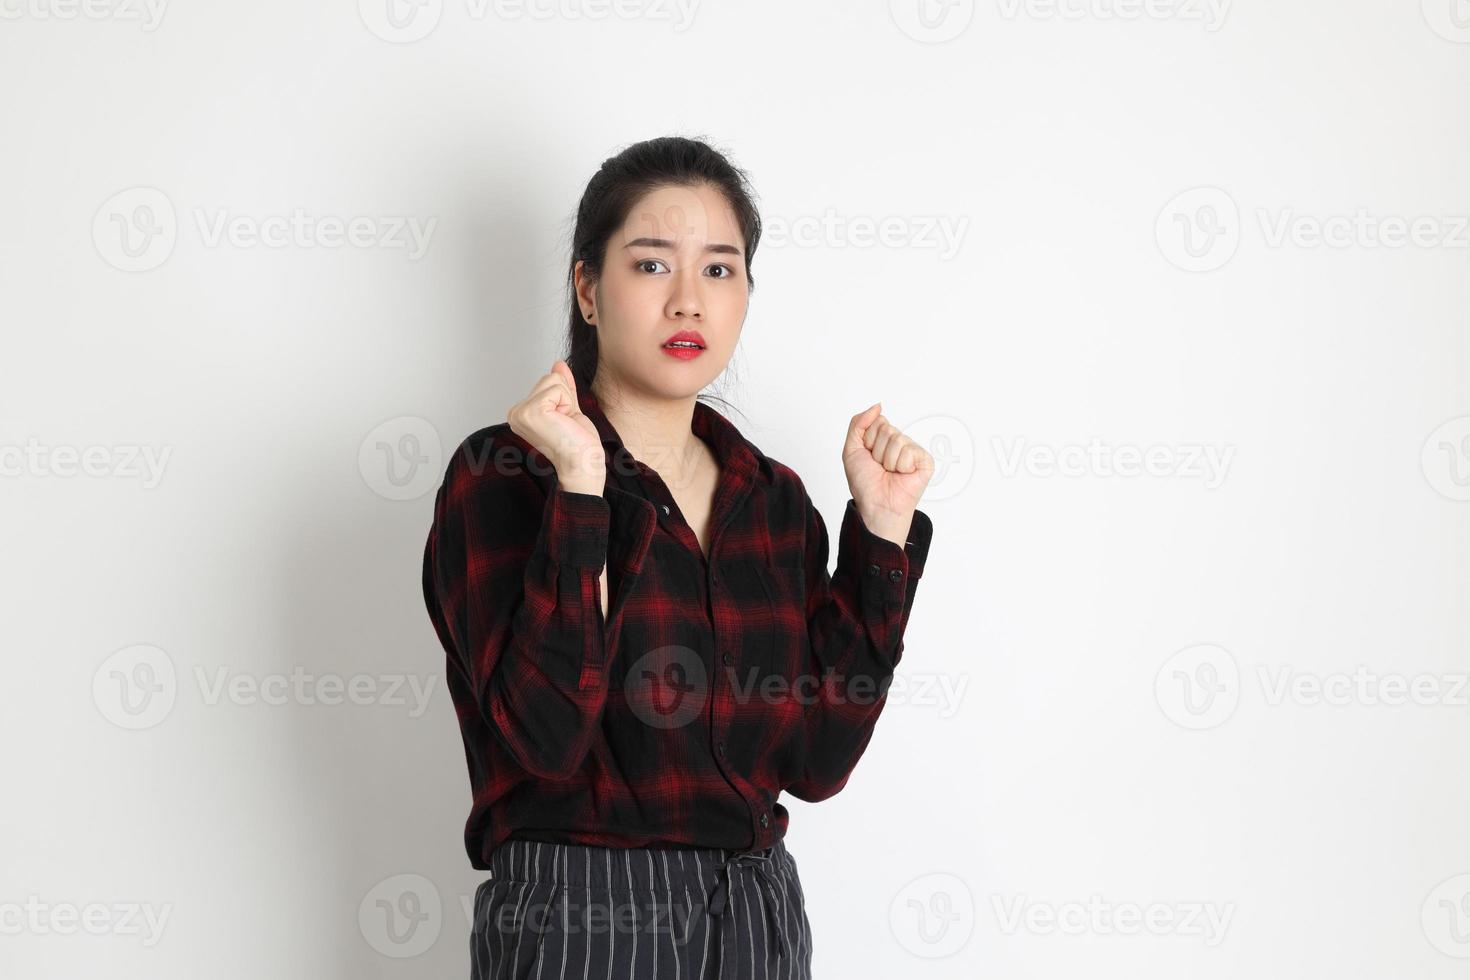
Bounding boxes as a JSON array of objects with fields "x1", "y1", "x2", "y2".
[{"x1": 470, "y1": 839, "x2": 811, "y2": 980}]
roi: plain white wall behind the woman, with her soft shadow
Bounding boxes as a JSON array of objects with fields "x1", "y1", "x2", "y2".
[{"x1": 0, "y1": 0, "x2": 1470, "y2": 980}]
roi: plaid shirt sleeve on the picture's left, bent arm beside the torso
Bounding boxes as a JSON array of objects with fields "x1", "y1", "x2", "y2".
[{"x1": 423, "y1": 436, "x2": 610, "y2": 779}]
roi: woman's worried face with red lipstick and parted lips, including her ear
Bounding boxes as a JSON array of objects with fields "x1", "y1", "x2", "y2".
[{"x1": 575, "y1": 184, "x2": 750, "y2": 398}]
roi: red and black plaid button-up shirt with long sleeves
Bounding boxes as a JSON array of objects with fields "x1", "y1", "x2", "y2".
[{"x1": 423, "y1": 389, "x2": 932, "y2": 870}]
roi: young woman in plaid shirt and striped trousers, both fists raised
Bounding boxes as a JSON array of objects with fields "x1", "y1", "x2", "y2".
[{"x1": 423, "y1": 138, "x2": 933, "y2": 980}]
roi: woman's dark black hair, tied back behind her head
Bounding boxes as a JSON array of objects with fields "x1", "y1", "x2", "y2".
[{"x1": 566, "y1": 137, "x2": 760, "y2": 405}]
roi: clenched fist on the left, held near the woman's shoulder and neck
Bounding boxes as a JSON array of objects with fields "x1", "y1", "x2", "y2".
[{"x1": 507, "y1": 360, "x2": 607, "y2": 497}]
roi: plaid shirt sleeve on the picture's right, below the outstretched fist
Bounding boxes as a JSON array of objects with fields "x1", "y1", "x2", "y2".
[{"x1": 786, "y1": 492, "x2": 933, "y2": 802}]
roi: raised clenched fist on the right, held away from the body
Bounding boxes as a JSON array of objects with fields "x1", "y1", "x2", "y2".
[{"x1": 842, "y1": 401, "x2": 933, "y2": 545}]
